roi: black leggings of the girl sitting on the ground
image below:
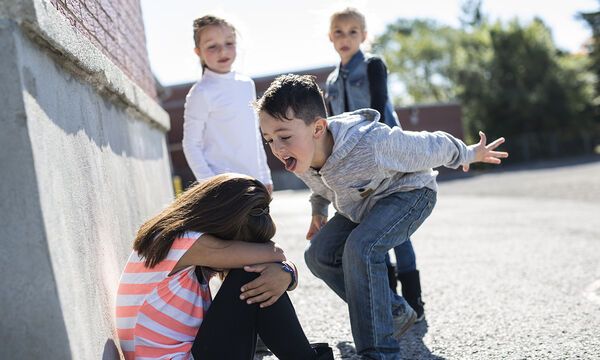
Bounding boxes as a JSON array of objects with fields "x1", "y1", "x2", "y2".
[{"x1": 192, "y1": 269, "x2": 316, "y2": 360}]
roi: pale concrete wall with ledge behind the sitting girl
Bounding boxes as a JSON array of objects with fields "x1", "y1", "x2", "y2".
[{"x1": 0, "y1": 0, "x2": 173, "y2": 359}]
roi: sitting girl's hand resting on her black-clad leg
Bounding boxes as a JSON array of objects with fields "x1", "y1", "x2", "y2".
[{"x1": 240, "y1": 263, "x2": 292, "y2": 308}]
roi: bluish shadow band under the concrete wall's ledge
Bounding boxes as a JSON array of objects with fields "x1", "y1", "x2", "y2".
[{"x1": 18, "y1": 28, "x2": 165, "y2": 160}]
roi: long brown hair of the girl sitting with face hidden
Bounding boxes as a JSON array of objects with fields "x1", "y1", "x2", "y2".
[{"x1": 133, "y1": 174, "x2": 275, "y2": 268}]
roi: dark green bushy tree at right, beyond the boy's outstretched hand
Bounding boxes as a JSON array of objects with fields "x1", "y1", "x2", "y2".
[{"x1": 456, "y1": 19, "x2": 591, "y2": 147}]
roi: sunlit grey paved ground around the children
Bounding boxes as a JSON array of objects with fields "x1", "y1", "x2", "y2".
[{"x1": 257, "y1": 159, "x2": 600, "y2": 360}]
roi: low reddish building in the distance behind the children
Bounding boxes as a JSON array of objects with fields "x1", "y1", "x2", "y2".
[{"x1": 162, "y1": 66, "x2": 464, "y2": 190}]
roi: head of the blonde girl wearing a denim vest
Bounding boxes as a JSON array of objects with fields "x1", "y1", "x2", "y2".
[{"x1": 329, "y1": 8, "x2": 367, "y2": 65}]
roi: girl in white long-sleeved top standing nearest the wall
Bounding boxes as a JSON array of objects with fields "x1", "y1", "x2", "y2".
[{"x1": 182, "y1": 15, "x2": 273, "y2": 191}]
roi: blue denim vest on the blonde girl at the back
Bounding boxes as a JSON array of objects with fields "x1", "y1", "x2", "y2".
[{"x1": 325, "y1": 50, "x2": 400, "y2": 127}]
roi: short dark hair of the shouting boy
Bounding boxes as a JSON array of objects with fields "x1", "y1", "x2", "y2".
[{"x1": 254, "y1": 74, "x2": 327, "y2": 125}]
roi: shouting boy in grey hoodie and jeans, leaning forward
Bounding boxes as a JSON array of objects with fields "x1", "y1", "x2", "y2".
[{"x1": 256, "y1": 75, "x2": 508, "y2": 359}]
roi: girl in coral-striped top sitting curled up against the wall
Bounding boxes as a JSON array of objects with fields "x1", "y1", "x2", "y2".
[{"x1": 116, "y1": 174, "x2": 333, "y2": 360}]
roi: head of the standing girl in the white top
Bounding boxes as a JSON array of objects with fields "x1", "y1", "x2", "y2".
[{"x1": 194, "y1": 15, "x2": 237, "y2": 74}]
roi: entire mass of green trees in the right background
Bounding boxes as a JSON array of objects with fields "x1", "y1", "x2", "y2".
[{"x1": 375, "y1": 12, "x2": 600, "y2": 158}]
